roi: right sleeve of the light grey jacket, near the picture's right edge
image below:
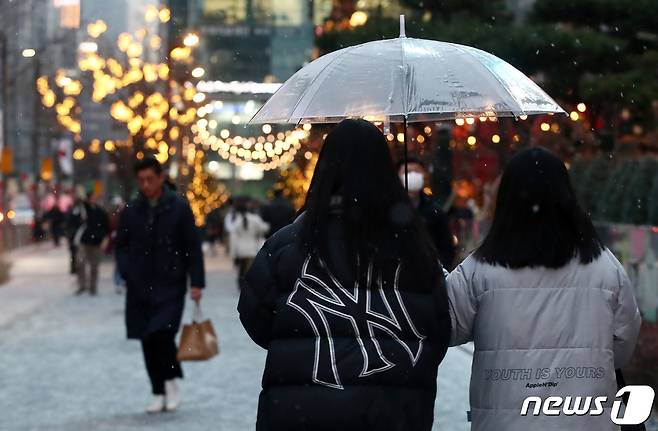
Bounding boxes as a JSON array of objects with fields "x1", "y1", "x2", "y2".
[{"x1": 613, "y1": 262, "x2": 642, "y2": 368}]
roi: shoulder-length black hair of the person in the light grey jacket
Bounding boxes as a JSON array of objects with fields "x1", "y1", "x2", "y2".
[{"x1": 475, "y1": 147, "x2": 603, "y2": 268}]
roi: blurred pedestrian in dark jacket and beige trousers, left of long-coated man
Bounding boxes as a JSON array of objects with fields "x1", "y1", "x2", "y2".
[{"x1": 73, "y1": 192, "x2": 110, "y2": 295}]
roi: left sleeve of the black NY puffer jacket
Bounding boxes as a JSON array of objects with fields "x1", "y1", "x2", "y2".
[{"x1": 238, "y1": 242, "x2": 276, "y2": 349}]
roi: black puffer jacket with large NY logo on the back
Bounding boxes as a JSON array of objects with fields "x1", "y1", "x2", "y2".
[{"x1": 238, "y1": 221, "x2": 450, "y2": 431}]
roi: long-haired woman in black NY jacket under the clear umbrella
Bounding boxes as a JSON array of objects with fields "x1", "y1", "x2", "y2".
[{"x1": 238, "y1": 120, "x2": 450, "y2": 431}]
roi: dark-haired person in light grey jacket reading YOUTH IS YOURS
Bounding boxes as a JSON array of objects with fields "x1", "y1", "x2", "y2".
[{"x1": 447, "y1": 147, "x2": 641, "y2": 431}]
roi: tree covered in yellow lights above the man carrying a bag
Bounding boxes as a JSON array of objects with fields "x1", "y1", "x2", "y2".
[{"x1": 79, "y1": 6, "x2": 205, "y2": 163}]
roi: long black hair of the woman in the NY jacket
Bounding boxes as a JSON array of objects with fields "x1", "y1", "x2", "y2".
[{"x1": 300, "y1": 120, "x2": 440, "y2": 290}]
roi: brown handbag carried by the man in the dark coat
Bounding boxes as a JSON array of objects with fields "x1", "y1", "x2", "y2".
[{"x1": 176, "y1": 302, "x2": 219, "y2": 361}]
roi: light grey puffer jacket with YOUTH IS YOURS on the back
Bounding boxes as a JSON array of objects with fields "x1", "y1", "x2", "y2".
[{"x1": 447, "y1": 249, "x2": 640, "y2": 431}]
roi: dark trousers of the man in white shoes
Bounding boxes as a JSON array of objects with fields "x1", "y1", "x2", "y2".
[{"x1": 142, "y1": 331, "x2": 183, "y2": 395}]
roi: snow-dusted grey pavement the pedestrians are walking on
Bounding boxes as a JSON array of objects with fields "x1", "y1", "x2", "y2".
[{"x1": 0, "y1": 247, "x2": 471, "y2": 431}]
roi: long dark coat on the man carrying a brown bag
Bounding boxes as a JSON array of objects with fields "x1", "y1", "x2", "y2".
[{"x1": 116, "y1": 188, "x2": 205, "y2": 338}]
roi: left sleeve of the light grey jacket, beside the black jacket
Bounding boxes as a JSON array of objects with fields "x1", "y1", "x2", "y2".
[{"x1": 446, "y1": 262, "x2": 477, "y2": 346}]
